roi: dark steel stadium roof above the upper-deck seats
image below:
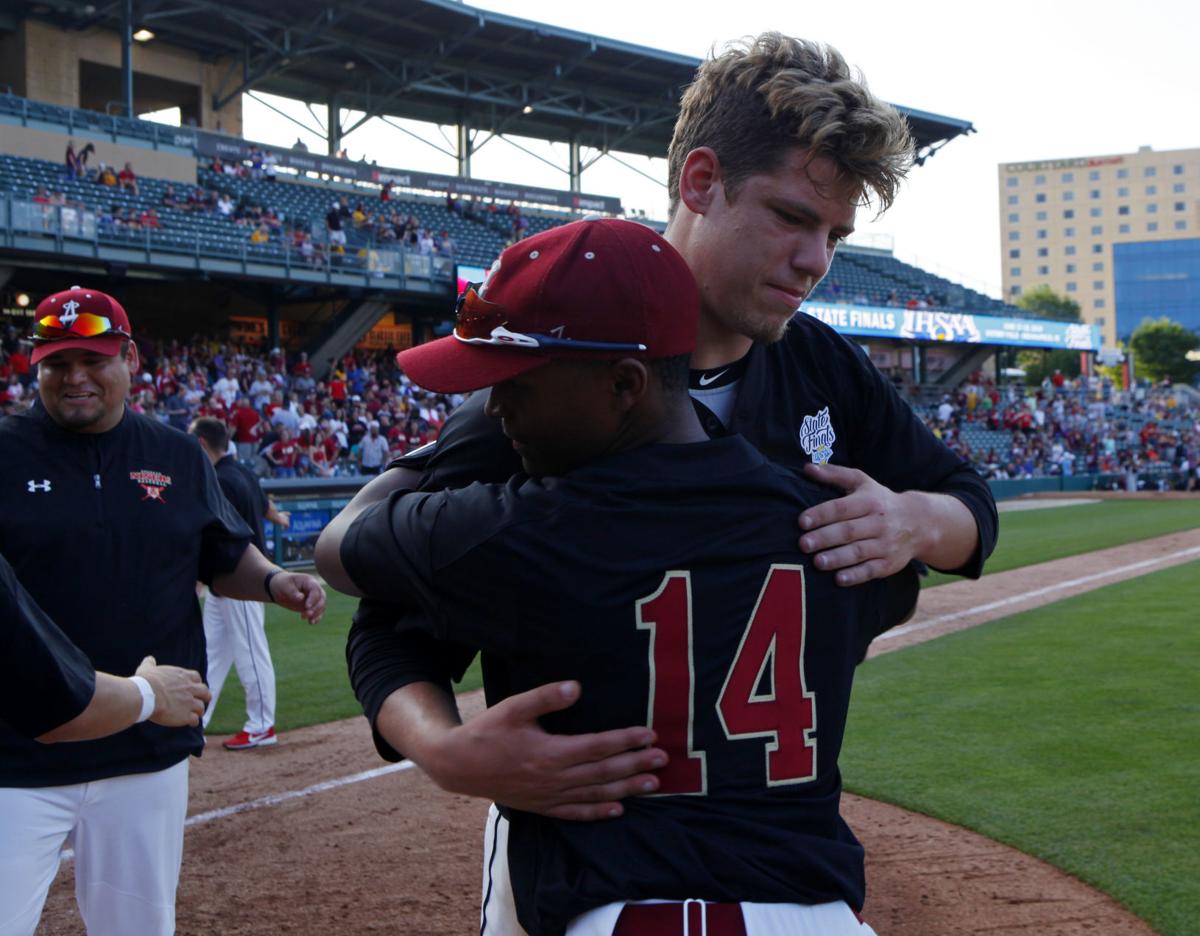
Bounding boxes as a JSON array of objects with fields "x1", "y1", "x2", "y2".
[{"x1": 5, "y1": 0, "x2": 974, "y2": 168}]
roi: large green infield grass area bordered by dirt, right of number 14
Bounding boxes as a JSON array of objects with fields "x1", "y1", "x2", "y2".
[{"x1": 841, "y1": 564, "x2": 1200, "y2": 936}]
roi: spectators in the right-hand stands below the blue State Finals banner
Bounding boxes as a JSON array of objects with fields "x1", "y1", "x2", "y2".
[{"x1": 924, "y1": 372, "x2": 1200, "y2": 490}]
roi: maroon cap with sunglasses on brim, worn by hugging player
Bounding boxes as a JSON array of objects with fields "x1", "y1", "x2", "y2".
[{"x1": 396, "y1": 218, "x2": 700, "y2": 394}]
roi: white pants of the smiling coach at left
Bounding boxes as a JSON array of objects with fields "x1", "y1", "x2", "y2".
[{"x1": 0, "y1": 758, "x2": 188, "y2": 936}]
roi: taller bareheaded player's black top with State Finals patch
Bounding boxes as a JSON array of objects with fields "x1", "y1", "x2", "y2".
[{"x1": 347, "y1": 314, "x2": 997, "y2": 715}]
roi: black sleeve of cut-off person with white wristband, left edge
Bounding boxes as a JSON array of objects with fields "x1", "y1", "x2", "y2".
[{"x1": 0, "y1": 556, "x2": 96, "y2": 738}]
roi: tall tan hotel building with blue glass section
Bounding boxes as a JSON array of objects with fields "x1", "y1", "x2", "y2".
[{"x1": 1000, "y1": 146, "x2": 1200, "y2": 344}]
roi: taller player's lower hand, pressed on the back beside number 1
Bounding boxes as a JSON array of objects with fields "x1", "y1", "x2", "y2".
[{"x1": 422, "y1": 682, "x2": 667, "y2": 821}]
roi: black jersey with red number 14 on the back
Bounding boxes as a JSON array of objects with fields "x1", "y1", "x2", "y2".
[{"x1": 341, "y1": 437, "x2": 883, "y2": 936}]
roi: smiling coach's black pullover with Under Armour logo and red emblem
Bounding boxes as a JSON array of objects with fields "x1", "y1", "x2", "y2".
[{"x1": 0, "y1": 401, "x2": 251, "y2": 787}]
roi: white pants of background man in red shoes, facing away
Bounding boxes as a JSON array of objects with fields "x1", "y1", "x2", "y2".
[{"x1": 204, "y1": 592, "x2": 275, "y2": 734}]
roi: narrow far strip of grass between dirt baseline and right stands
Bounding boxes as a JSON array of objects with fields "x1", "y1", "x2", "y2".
[{"x1": 924, "y1": 494, "x2": 1200, "y2": 588}]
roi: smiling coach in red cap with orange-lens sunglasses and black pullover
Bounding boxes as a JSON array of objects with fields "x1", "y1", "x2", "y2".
[{"x1": 0, "y1": 287, "x2": 324, "y2": 936}]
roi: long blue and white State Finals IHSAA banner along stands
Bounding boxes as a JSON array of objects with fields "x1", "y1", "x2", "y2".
[{"x1": 800, "y1": 302, "x2": 1100, "y2": 352}]
